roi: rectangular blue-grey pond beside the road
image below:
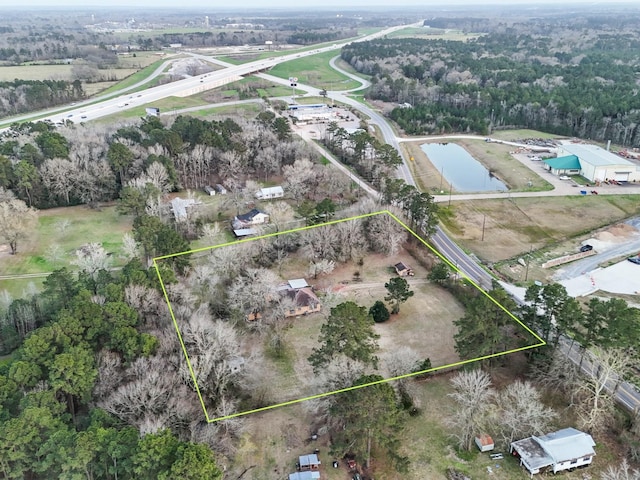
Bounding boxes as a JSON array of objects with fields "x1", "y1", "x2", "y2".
[{"x1": 420, "y1": 143, "x2": 509, "y2": 192}]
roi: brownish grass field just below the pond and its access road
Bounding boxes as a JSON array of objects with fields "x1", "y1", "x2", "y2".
[{"x1": 441, "y1": 195, "x2": 640, "y2": 266}]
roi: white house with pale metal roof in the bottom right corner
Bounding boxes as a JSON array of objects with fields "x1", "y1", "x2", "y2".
[{"x1": 509, "y1": 428, "x2": 596, "y2": 477}]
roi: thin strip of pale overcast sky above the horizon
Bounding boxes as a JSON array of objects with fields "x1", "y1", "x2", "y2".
[{"x1": 6, "y1": 0, "x2": 637, "y2": 8}]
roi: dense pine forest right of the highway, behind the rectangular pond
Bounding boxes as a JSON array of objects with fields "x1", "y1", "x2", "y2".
[{"x1": 342, "y1": 12, "x2": 640, "y2": 146}]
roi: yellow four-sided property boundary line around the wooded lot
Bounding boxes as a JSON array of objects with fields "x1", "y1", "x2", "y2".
[{"x1": 153, "y1": 210, "x2": 546, "y2": 423}]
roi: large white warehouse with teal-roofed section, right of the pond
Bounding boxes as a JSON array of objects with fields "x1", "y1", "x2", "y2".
[{"x1": 545, "y1": 143, "x2": 640, "y2": 182}]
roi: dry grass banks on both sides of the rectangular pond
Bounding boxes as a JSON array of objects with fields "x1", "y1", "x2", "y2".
[{"x1": 403, "y1": 139, "x2": 553, "y2": 193}]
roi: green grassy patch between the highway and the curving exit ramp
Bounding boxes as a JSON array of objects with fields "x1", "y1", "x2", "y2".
[{"x1": 269, "y1": 52, "x2": 360, "y2": 90}]
